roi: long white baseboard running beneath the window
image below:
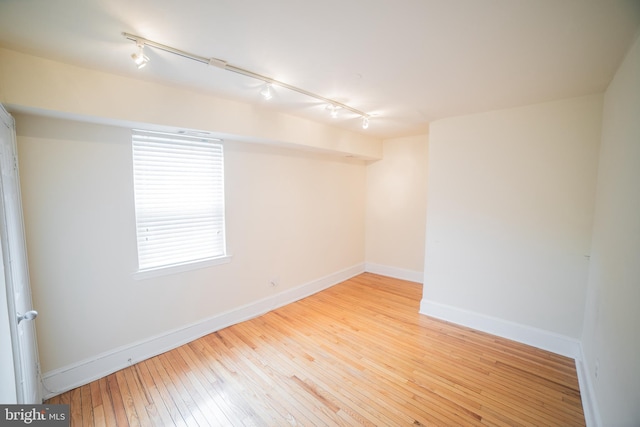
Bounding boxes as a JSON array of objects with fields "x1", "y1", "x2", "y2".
[{"x1": 42, "y1": 264, "x2": 364, "y2": 399}]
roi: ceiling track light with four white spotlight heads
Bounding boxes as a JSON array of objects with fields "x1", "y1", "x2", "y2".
[{"x1": 122, "y1": 33, "x2": 371, "y2": 129}]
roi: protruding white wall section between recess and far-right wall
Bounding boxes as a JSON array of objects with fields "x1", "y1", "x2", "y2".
[{"x1": 422, "y1": 95, "x2": 602, "y2": 338}]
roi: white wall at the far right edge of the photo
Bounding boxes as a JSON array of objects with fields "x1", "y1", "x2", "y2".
[{"x1": 582, "y1": 38, "x2": 640, "y2": 426}]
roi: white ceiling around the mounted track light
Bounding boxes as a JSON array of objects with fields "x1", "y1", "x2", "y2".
[{"x1": 0, "y1": 0, "x2": 640, "y2": 138}]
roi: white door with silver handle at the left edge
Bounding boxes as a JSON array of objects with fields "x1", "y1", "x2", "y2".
[{"x1": 0, "y1": 105, "x2": 42, "y2": 403}]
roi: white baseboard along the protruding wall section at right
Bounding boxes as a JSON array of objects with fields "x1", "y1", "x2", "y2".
[{"x1": 420, "y1": 299, "x2": 582, "y2": 361}]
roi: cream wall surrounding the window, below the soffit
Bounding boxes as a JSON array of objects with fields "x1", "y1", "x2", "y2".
[{"x1": 16, "y1": 114, "x2": 366, "y2": 373}]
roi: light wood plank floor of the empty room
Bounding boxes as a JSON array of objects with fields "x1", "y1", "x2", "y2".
[{"x1": 49, "y1": 273, "x2": 585, "y2": 426}]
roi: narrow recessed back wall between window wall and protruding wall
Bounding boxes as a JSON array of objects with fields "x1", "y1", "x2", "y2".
[{"x1": 366, "y1": 135, "x2": 428, "y2": 282}]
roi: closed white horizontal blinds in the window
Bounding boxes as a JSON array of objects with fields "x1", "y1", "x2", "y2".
[{"x1": 132, "y1": 130, "x2": 225, "y2": 271}]
